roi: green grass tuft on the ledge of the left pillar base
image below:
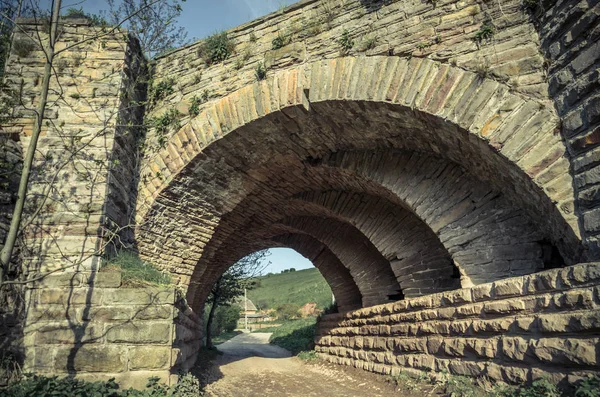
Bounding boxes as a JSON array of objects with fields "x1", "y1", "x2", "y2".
[{"x1": 103, "y1": 251, "x2": 172, "y2": 285}]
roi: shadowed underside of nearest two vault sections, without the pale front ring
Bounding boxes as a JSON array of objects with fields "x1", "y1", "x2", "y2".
[{"x1": 138, "y1": 96, "x2": 579, "y2": 312}]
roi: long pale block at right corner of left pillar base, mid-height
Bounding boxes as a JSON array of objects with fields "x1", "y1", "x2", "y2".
[{"x1": 104, "y1": 321, "x2": 172, "y2": 344}]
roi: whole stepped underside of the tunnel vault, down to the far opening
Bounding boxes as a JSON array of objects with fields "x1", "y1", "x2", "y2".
[{"x1": 139, "y1": 61, "x2": 580, "y2": 316}]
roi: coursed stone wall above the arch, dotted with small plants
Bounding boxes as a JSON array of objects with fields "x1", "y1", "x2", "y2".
[{"x1": 147, "y1": 0, "x2": 547, "y2": 158}]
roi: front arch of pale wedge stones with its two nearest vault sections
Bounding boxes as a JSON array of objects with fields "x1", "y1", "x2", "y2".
[{"x1": 137, "y1": 57, "x2": 580, "y2": 316}]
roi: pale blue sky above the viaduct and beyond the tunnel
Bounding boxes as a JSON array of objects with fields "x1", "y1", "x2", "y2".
[{"x1": 57, "y1": 0, "x2": 313, "y2": 274}]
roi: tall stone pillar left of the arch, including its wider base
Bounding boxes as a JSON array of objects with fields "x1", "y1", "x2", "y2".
[{"x1": 0, "y1": 18, "x2": 151, "y2": 381}]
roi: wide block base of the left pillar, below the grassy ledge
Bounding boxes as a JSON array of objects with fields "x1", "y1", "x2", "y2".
[{"x1": 24, "y1": 272, "x2": 199, "y2": 388}]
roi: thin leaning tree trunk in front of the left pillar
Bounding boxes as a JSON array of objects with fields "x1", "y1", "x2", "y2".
[{"x1": 0, "y1": 0, "x2": 61, "y2": 285}]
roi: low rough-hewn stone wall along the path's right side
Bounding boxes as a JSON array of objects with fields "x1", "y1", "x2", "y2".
[{"x1": 315, "y1": 263, "x2": 600, "y2": 383}]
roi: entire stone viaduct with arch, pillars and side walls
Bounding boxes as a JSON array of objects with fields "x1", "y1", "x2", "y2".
[{"x1": 0, "y1": 0, "x2": 600, "y2": 384}]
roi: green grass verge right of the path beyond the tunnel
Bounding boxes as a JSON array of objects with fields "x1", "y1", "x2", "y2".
[{"x1": 256, "y1": 317, "x2": 317, "y2": 355}]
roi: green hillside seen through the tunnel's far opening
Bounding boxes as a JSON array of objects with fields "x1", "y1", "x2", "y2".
[{"x1": 248, "y1": 268, "x2": 331, "y2": 309}]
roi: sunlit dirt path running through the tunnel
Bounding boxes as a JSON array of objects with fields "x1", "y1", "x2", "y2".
[{"x1": 206, "y1": 333, "x2": 436, "y2": 397}]
